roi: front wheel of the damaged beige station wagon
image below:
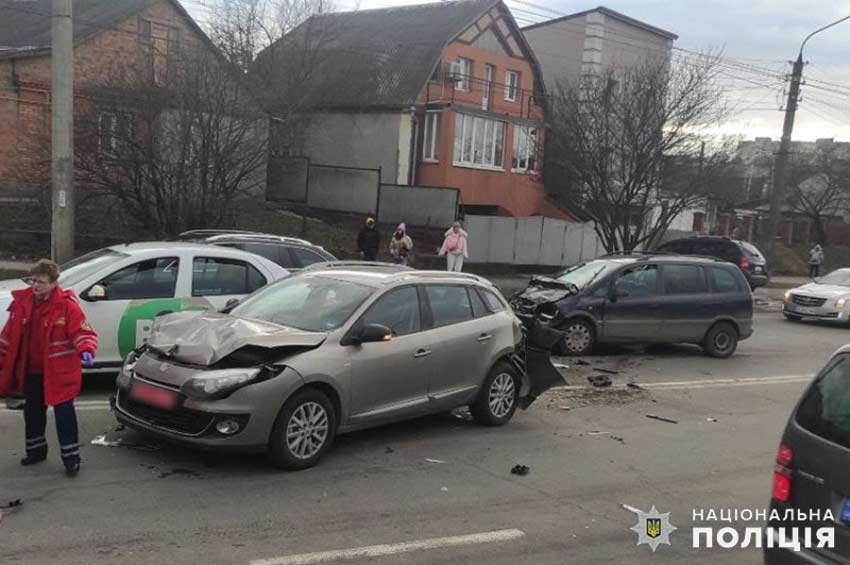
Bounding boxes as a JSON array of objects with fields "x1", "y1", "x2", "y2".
[{"x1": 267, "y1": 388, "x2": 337, "y2": 471}]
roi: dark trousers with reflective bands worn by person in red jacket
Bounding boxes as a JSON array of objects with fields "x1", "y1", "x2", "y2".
[{"x1": 24, "y1": 375, "x2": 80, "y2": 467}]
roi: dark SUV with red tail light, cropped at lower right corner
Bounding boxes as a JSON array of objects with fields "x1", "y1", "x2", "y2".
[{"x1": 763, "y1": 346, "x2": 850, "y2": 565}]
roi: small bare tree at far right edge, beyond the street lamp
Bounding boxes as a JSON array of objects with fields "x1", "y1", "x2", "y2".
[{"x1": 789, "y1": 147, "x2": 850, "y2": 245}]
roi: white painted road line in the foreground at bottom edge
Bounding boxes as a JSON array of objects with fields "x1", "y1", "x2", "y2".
[{"x1": 250, "y1": 530, "x2": 525, "y2": 565}]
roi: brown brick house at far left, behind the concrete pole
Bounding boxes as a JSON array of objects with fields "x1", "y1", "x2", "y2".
[{"x1": 0, "y1": 0, "x2": 214, "y2": 198}]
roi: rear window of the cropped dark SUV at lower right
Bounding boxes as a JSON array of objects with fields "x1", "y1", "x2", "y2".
[{"x1": 797, "y1": 355, "x2": 850, "y2": 449}]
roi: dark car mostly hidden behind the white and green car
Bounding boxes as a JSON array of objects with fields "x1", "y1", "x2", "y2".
[{"x1": 179, "y1": 230, "x2": 337, "y2": 272}]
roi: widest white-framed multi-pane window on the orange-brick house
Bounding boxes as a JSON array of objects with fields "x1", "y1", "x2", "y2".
[{"x1": 452, "y1": 112, "x2": 507, "y2": 171}]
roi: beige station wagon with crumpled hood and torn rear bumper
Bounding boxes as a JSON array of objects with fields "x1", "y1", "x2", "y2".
[{"x1": 114, "y1": 262, "x2": 564, "y2": 469}]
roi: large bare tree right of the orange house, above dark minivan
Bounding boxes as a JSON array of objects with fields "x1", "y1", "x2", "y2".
[{"x1": 544, "y1": 55, "x2": 731, "y2": 252}]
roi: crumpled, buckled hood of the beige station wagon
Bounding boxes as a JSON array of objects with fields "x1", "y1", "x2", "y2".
[{"x1": 148, "y1": 311, "x2": 327, "y2": 367}]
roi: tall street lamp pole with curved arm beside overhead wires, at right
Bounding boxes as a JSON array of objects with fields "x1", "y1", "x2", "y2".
[{"x1": 765, "y1": 16, "x2": 850, "y2": 265}]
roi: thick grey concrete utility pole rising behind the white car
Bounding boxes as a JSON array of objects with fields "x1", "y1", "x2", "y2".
[{"x1": 50, "y1": 0, "x2": 74, "y2": 263}]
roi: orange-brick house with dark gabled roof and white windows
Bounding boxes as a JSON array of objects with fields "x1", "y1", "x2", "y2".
[{"x1": 257, "y1": 0, "x2": 566, "y2": 218}]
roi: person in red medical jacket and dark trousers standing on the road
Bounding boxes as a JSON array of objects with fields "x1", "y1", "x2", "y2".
[{"x1": 0, "y1": 260, "x2": 97, "y2": 477}]
